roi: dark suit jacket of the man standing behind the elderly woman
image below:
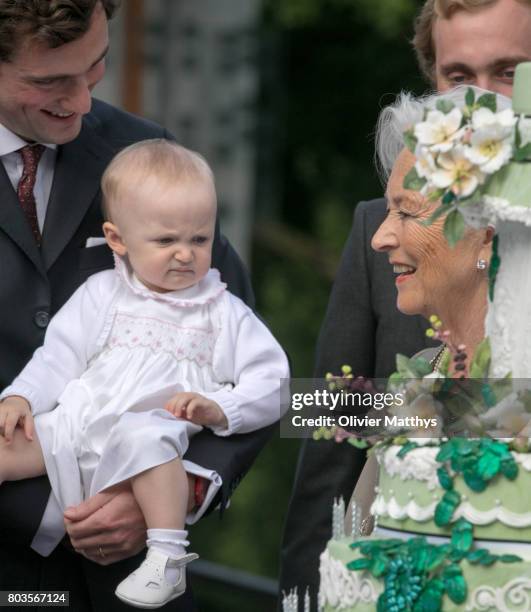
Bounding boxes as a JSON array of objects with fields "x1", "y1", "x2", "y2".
[{"x1": 280, "y1": 199, "x2": 436, "y2": 597}]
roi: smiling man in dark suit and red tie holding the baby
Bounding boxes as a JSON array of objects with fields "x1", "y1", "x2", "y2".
[{"x1": 0, "y1": 0, "x2": 271, "y2": 611}]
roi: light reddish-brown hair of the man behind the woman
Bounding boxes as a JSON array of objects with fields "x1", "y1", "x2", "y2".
[{"x1": 413, "y1": 0, "x2": 531, "y2": 83}]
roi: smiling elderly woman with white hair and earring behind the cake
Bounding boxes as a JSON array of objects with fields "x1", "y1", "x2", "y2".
[{"x1": 353, "y1": 87, "x2": 510, "y2": 532}]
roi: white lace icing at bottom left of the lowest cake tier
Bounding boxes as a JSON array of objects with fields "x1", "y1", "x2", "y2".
[{"x1": 319, "y1": 550, "x2": 382, "y2": 610}]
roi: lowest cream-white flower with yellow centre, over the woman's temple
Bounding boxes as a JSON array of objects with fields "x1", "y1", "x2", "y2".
[{"x1": 430, "y1": 145, "x2": 485, "y2": 198}]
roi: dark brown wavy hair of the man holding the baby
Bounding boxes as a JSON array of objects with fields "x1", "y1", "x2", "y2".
[{"x1": 0, "y1": 0, "x2": 120, "y2": 62}]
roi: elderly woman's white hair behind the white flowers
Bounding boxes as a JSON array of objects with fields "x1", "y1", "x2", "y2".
[{"x1": 375, "y1": 85, "x2": 511, "y2": 186}]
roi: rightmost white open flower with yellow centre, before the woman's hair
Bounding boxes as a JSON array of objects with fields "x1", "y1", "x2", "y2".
[{"x1": 465, "y1": 108, "x2": 516, "y2": 174}]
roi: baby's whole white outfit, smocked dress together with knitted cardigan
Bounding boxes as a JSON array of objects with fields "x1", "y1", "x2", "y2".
[{"x1": 1, "y1": 259, "x2": 288, "y2": 552}]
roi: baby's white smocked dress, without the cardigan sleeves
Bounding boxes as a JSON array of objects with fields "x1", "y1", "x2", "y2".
[{"x1": 36, "y1": 264, "x2": 229, "y2": 508}]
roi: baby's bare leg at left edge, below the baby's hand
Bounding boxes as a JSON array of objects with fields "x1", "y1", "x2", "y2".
[{"x1": 0, "y1": 427, "x2": 46, "y2": 483}]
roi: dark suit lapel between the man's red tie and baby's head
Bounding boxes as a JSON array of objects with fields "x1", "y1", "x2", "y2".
[{"x1": 41, "y1": 121, "x2": 114, "y2": 270}]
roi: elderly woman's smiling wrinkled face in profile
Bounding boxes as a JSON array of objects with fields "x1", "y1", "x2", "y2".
[{"x1": 372, "y1": 149, "x2": 489, "y2": 317}]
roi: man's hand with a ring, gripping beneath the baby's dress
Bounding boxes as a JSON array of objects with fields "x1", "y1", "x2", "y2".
[{"x1": 64, "y1": 474, "x2": 195, "y2": 565}]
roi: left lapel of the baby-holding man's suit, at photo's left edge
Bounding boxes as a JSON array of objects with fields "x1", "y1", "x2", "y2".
[{"x1": 0, "y1": 163, "x2": 44, "y2": 273}]
